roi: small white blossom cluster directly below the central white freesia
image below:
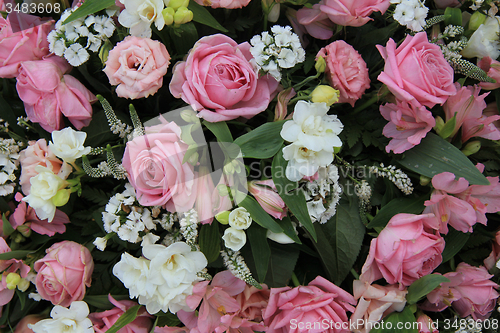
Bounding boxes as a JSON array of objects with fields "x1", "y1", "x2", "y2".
[{"x1": 302, "y1": 164, "x2": 342, "y2": 224}]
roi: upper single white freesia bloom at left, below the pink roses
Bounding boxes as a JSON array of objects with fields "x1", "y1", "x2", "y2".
[{"x1": 49, "y1": 127, "x2": 90, "y2": 163}]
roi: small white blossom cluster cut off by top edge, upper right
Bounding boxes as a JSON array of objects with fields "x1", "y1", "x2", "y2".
[{"x1": 391, "y1": 0, "x2": 429, "y2": 31}]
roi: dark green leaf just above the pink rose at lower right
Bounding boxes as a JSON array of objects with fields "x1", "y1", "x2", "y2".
[{"x1": 367, "y1": 195, "x2": 429, "y2": 232}]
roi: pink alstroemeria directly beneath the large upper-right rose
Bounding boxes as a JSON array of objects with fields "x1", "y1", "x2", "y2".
[{"x1": 380, "y1": 101, "x2": 436, "y2": 154}]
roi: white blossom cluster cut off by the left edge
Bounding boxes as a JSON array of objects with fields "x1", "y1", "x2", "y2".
[{"x1": 0, "y1": 138, "x2": 19, "y2": 196}]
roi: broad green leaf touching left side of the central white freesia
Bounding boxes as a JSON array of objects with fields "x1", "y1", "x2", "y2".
[{"x1": 234, "y1": 120, "x2": 284, "y2": 159}]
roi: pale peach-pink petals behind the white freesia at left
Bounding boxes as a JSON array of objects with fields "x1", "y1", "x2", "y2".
[{"x1": 19, "y1": 139, "x2": 63, "y2": 195}]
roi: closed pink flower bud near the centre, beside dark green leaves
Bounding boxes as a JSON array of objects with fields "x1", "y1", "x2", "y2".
[{"x1": 248, "y1": 179, "x2": 286, "y2": 220}]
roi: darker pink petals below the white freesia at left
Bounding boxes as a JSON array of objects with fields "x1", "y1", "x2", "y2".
[{"x1": 9, "y1": 193, "x2": 70, "y2": 237}]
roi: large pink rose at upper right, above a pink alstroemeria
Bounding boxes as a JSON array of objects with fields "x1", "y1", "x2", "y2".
[{"x1": 377, "y1": 32, "x2": 456, "y2": 108}]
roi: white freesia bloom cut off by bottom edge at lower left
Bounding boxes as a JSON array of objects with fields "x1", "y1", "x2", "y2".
[{"x1": 28, "y1": 301, "x2": 95, "y2": 333}]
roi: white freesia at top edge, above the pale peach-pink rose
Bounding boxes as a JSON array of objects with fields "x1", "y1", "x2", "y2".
[{"x1": 118, "y1": 0, "x2": 165, "y2": 38}]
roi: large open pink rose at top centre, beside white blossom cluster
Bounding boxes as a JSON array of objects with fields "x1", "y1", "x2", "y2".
[{"x1": 169, "y1": 34, "x2": 278, "y2": 122}]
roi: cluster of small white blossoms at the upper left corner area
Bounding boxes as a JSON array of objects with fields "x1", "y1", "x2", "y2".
[{"x1": 47, "y1": 9, "x2": 115, "y2": 66}]
